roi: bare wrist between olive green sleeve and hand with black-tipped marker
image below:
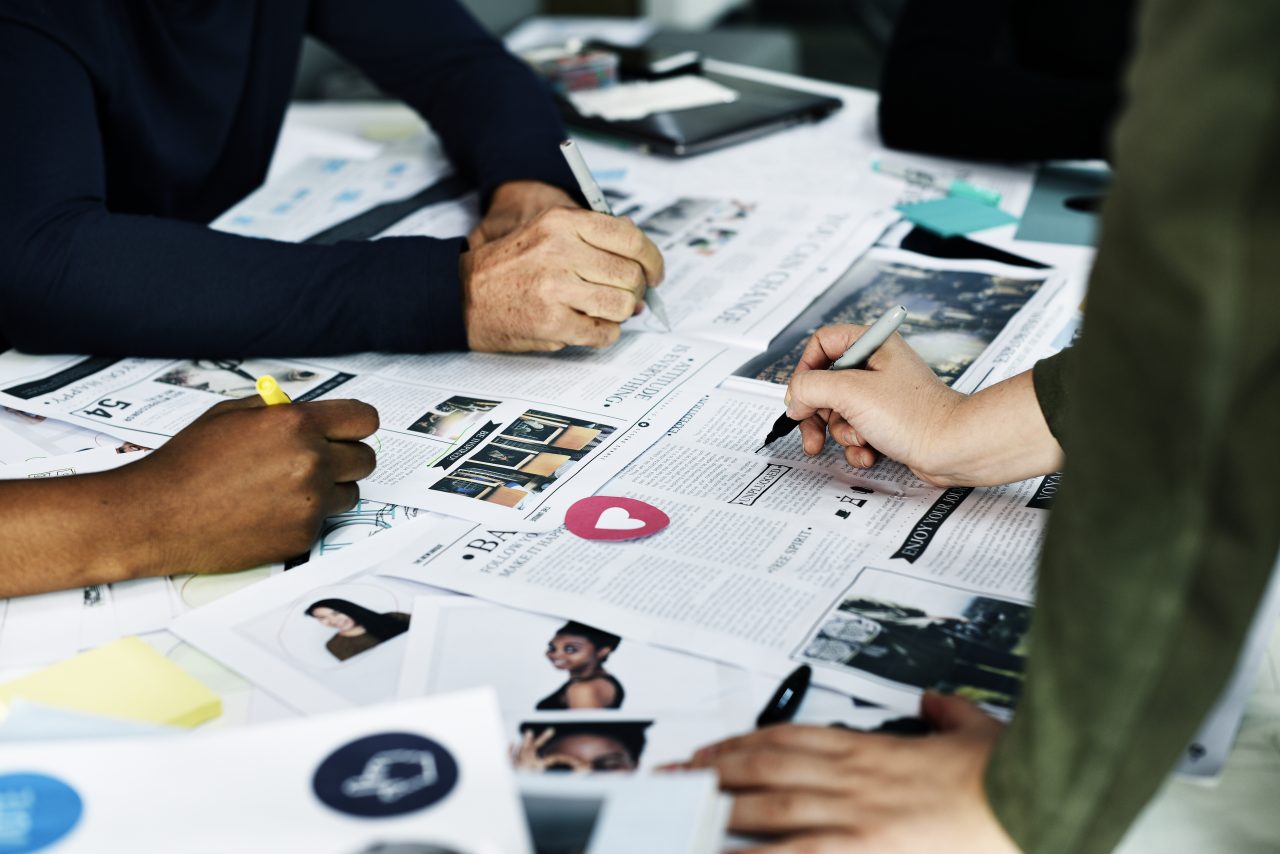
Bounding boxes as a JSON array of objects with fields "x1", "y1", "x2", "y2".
[{"x1": 923, "y1": 371, "x2": 1062, "y2": 487}]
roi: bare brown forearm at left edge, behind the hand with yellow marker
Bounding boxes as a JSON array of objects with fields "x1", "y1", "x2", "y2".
[{"x1": 0, "y1": 470, "x2": 161, "y2": 598}]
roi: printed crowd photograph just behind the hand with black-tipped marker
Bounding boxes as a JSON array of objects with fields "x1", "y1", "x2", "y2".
[{"x1": 736, "y1": 251, "x2": 1044, "y2": 385}]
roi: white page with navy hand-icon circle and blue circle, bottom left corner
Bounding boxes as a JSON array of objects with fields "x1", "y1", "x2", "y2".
[{"x1": 0, "y1": 691, "x2": 532, "y2": 854}]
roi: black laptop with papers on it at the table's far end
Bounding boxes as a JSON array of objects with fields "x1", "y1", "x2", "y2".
[{"x1": 557, "y1": 72, "x2": 841, "y2": 157}]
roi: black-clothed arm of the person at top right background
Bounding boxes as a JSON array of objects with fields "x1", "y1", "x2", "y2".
[{"x1": 879, "y1": 0, "x2": 1135, "y2": 160}]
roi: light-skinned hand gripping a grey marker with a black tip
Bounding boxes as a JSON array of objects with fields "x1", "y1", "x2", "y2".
[{"x1": 787, "y1": 324, "x2": 965, "y2": 485}]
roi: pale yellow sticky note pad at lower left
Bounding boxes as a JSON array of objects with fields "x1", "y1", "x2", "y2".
[{"x1": 0, "y1": 638, "x2": 223, "y2": 727}]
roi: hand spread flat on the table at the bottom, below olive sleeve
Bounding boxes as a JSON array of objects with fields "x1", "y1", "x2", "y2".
[{"x1": 682, "y1": 694, "x2": 1018, "y2": 854}]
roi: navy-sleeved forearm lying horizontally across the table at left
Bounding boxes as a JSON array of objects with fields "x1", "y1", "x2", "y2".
[{"x1": 0, "y1": 205, "x2": 465, "y2": 357}]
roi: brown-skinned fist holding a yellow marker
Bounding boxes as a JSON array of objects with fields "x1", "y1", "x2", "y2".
[{"x1": 118, "y1": 397, "x2": 378, "y2": 574}]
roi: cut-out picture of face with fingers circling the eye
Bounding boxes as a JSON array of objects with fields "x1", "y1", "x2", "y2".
[{"x1": 512, "y1": 721, "x2": 653, "y2": 773}]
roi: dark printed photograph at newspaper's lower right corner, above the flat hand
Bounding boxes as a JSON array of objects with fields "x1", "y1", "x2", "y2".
[{"x1": 799, "y1": 570, "x2": 1032, "y2": 712}]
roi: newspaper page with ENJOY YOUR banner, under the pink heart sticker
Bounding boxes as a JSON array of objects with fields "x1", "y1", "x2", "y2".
[{"x1": 381, "y1": 391, "x2": 1052, "y2": 714}]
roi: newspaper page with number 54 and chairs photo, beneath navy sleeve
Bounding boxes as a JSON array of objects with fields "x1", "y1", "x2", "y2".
[{"x1": 0, "y1": 333, "x2": 749, "y2": 530}]
